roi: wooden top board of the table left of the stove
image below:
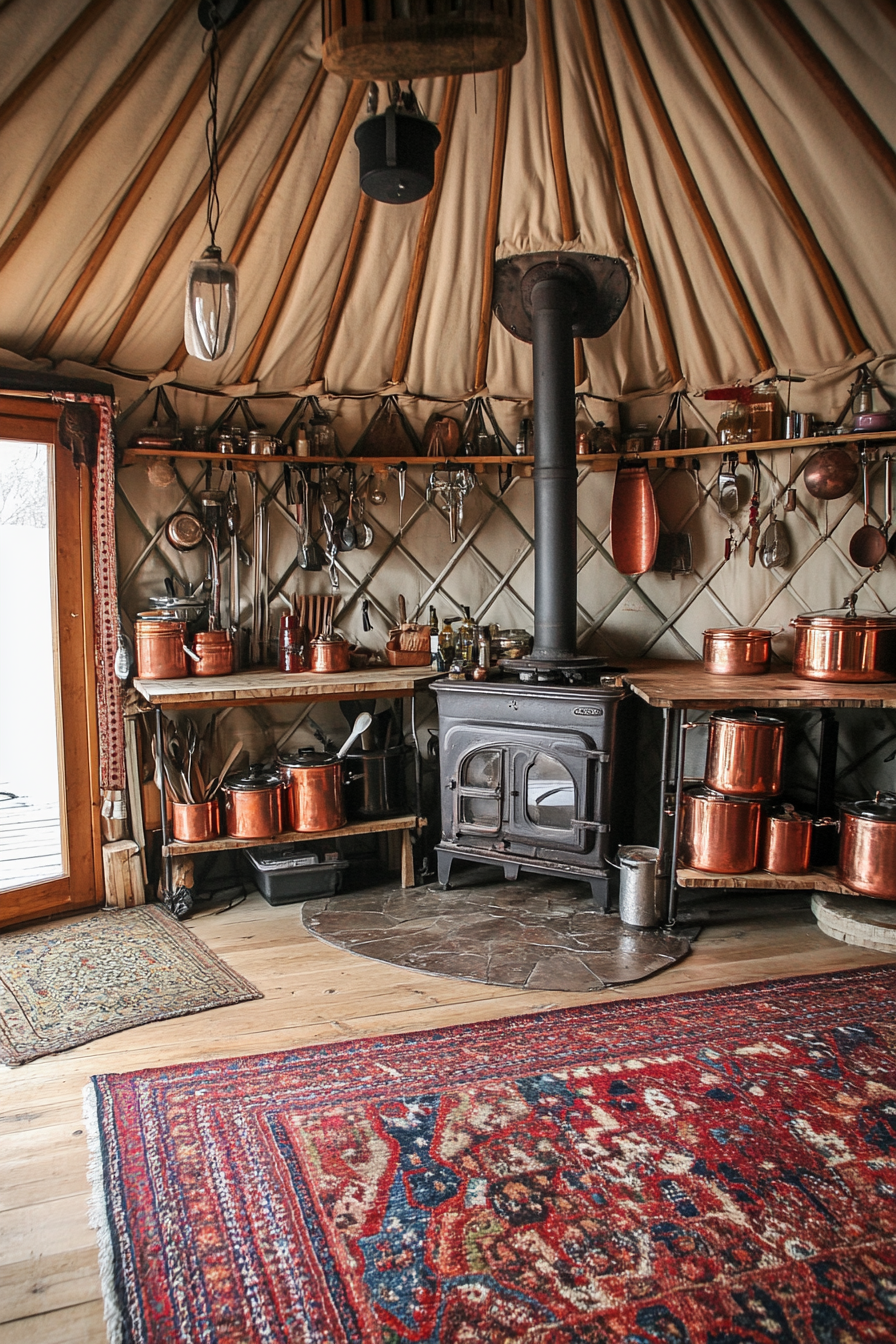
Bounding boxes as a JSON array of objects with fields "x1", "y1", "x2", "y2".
[{"x1": 134, "y1": 667, "x2": 441, "y2": 710}]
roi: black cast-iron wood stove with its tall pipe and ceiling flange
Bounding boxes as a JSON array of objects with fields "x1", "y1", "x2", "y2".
[{"x1": 434, "y1": 253, "x2": 629, "y2": 910}]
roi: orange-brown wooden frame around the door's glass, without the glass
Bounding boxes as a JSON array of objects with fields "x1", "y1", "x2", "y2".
[{"x1": 0, "y1": 394, "x2": 103, "y2": 927}]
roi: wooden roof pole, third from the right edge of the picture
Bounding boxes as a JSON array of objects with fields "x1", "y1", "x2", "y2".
[{"x1": 602, "y1": 0, "x2": 772, "y2": 370}]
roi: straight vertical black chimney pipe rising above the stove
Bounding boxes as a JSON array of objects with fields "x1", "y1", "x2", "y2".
[{"x1": 531, "y1": 273, "x2": 578, "y2": 661}]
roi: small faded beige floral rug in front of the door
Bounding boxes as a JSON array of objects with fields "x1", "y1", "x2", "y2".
[{"x1": 0, "y1": 906, "x2": 262, "y2": 1064}]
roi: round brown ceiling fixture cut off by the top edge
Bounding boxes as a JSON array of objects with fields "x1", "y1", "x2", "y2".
[{"x1": 322, "y1": 0, "x2": 525, "y2": 79}]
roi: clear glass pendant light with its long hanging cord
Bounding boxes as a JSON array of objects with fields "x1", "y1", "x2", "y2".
[{"x1": 184, "y1": 5, "x2": 238, "y2": 363}]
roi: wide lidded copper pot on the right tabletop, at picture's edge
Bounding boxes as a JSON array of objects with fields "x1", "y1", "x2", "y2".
[{"x1": 790, "y1": 612, "x2": 896, "y2": 681}]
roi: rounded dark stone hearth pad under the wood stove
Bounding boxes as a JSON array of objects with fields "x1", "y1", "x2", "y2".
[{"x1": 302, "y1": 878, "x2": 697, "y2": 993}]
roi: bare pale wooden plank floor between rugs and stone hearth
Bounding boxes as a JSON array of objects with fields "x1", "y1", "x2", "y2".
[{"x1": 0, "y1": 892, "x2": 893, "y2": 1344}]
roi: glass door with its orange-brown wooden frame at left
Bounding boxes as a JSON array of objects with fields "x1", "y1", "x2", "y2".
[{"x1": 0, "y1": 401, "x2": 98, "y2": 925}]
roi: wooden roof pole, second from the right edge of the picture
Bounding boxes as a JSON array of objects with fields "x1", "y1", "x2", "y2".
[{"x1": 666, "y1": 0, "x2": 868, "y2": 355}]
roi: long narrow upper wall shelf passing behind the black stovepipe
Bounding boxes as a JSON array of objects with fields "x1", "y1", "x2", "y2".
[{"x1": 121, "y1": 429, "x2": 896, "y2": 472}]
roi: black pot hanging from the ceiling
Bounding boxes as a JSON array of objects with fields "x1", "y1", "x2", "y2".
[{"x1": 355, "y1": 108, "x2": 442, "y2": 206}]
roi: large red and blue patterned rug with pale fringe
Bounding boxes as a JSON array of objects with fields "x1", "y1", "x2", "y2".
[{"x1": 86, "y1": 966, "x2": 896, "y2": 1344}]
